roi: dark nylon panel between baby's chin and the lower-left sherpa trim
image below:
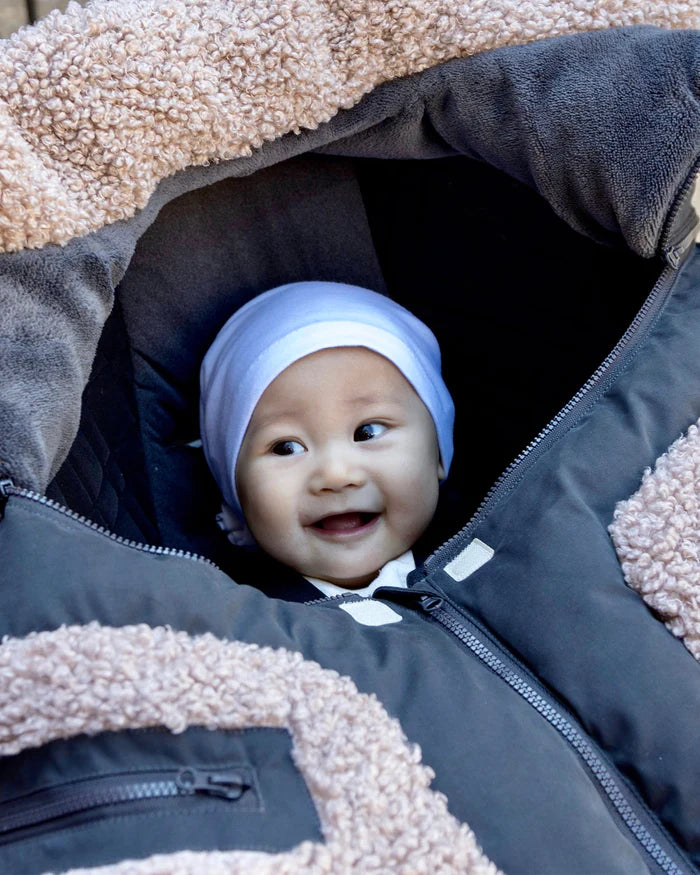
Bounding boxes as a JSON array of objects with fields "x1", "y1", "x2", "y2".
[{"x1": 0, "y1": 498, "x2": 672, "y2": 875}]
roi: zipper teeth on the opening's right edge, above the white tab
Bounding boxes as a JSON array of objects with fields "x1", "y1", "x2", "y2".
[{"x1": 424, "y1": 260, "x2": 676, "y2": 568}]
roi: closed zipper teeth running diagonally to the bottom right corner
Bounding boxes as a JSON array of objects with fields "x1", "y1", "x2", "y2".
[{"x1": 430, "y1": 607, "x2": 682, "y2": 875}]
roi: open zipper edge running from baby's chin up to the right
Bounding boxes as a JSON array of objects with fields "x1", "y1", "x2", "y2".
[{"x1": 423, "y1": 256, "x2": 680, "y2": 574}]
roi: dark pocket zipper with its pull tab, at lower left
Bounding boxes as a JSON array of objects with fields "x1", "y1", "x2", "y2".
[{"x1": 0, "y1": 767, "x2": 252, "y2": 836}]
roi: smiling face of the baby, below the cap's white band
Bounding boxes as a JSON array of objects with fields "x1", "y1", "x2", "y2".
[{"x1": 236, "y1": 347, "x2": 444, "y2": 587}]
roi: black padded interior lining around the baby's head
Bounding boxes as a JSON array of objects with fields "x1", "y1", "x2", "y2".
[{"x1": 46, "y1": 149, "x2": 660, "y2": 580}]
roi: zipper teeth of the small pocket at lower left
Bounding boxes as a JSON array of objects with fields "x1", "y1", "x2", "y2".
[{"x1": 0, "y1": 780, "x2": 180, "y2": 833}]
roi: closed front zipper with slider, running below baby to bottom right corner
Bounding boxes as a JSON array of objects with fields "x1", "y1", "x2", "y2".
[{"x1": 410, "y1": 590, "x2": 693, "y2": 875}]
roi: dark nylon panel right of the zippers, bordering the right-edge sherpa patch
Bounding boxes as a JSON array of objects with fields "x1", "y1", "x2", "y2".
[{"x1": 435, "y1": 249, "x2": 700, "y2": 863}]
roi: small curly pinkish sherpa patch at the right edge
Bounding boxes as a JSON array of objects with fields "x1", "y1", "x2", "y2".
[{"x1": 610, "y1": 423, "x2": 700, "y2": 660}]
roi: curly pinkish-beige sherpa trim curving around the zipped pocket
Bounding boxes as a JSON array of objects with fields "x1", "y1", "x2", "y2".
[{"x1": 0, "y1": 623, "x2": 504, "y2": 875}]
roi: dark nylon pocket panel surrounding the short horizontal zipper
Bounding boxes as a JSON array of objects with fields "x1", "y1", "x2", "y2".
[{"x1": 0, "y1": 727, "x2": 323, "y2": 875}]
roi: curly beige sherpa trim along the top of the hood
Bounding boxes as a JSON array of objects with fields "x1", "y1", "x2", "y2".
[{"x1": 0, "y1": 0, "x2": 700, "y2": 251}]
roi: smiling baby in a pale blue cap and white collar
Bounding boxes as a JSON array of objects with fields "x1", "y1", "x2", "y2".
[{"x1": 200, "y1": 282, "x2": 454, "y2": 595}]
